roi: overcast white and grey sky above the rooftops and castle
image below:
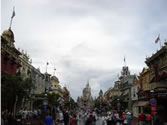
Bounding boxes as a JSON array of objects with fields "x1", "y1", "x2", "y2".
[{"x1": 1, "y1": 0, "x2": 167, "y2": 99}]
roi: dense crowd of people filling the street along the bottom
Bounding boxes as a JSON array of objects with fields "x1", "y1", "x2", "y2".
[{"x1": 1, "y1": 107, "x2": 160, "y2": 125}]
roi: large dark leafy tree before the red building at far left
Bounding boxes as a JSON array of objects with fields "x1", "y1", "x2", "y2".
[{"x1": 1, "y1": 73, "x2": 34, "y2": 112}]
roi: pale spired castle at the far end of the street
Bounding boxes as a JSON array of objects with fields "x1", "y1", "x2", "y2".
[{"x1": 77, "y1": 81, "x2": 94, "y2": 108}]
